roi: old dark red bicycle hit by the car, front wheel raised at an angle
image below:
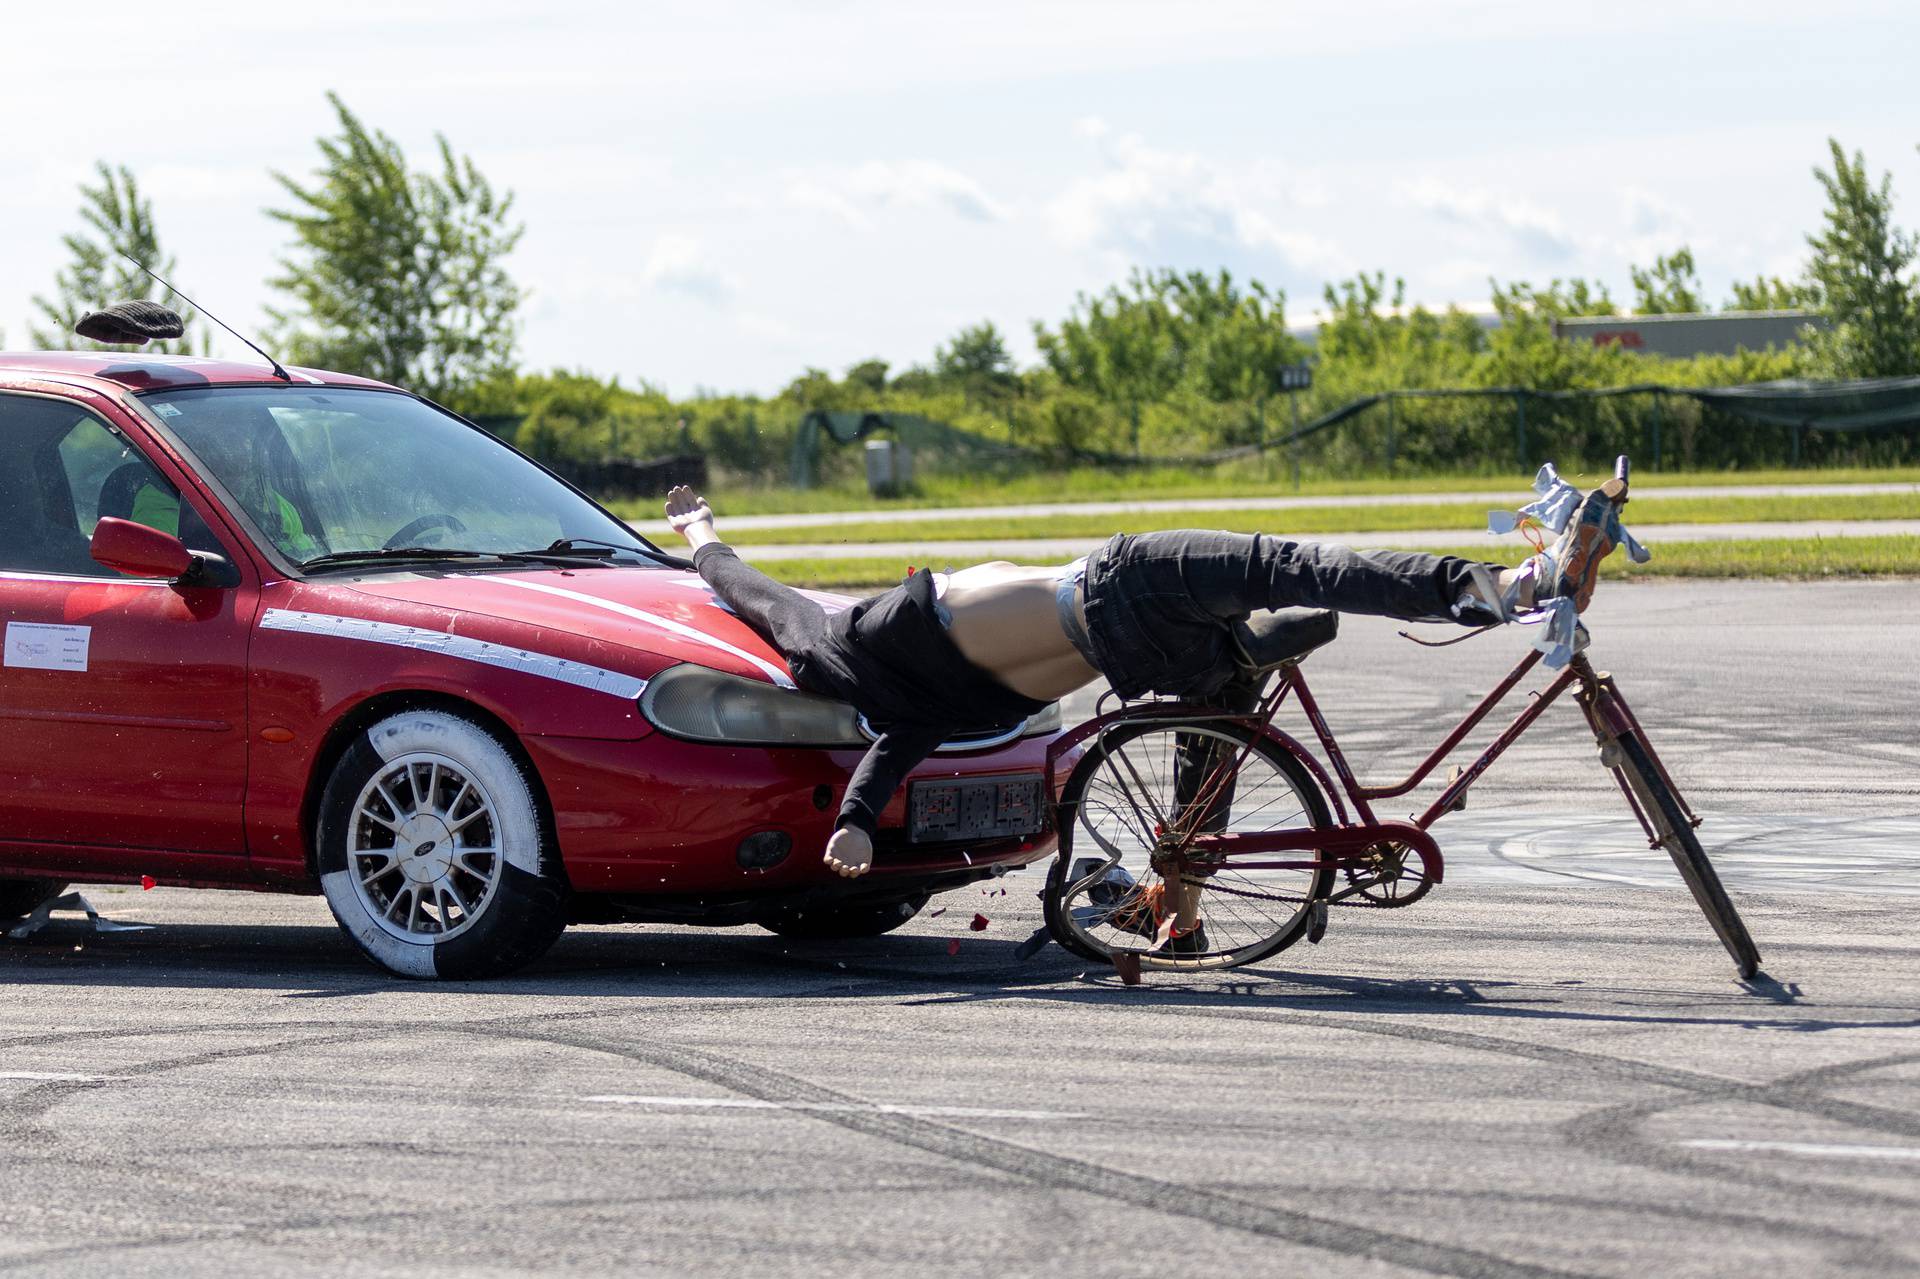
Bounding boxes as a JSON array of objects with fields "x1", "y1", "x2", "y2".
[{"x1": 1043, "y1": 457, "x2": 1761, "y2": 979}]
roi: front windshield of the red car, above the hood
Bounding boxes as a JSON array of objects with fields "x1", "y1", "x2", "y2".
[{"x1": 146, "y1": 386, "x2": 647, "y2": 563}]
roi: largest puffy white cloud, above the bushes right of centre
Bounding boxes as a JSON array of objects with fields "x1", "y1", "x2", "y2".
[{"x1": 1046, "y1": 117, "x2": 1350, "y2": 280}]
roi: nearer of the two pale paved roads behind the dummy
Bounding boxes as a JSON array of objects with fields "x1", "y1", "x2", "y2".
[{"x1": 737, "y1": 519, "x2": 1920, "y2": 565}]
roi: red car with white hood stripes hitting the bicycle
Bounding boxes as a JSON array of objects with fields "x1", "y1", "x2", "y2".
[{"x1": 0, "y1": 353, "x2": 1058, "y2": 977}]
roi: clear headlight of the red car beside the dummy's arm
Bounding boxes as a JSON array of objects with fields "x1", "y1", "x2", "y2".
[{"x1": 639, "y1": 664, "x2": 866, "y2": 747}]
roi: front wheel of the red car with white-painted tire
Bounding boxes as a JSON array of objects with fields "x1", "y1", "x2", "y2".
[{"x1": 315, "y1": 711, "x2": 566, "y2": 981}]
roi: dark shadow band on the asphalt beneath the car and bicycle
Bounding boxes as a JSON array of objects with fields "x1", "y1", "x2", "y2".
[{"x1": 0, "y1": 922, "x2": 1889, "y2": 1031}]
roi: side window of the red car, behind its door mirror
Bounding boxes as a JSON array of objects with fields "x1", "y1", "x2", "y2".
[{"x1": 0, "y1": 396, "x2": 219, "y2": 578}]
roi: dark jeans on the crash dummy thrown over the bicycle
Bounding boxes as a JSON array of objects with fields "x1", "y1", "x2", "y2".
[{"x1": 1085, "y1": 530, "x2": 1500, "y2": 697}]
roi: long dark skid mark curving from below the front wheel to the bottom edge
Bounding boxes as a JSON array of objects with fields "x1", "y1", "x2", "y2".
[{"x1": 476, "y1": 1027, "x2": 1578, "y2": 1279}]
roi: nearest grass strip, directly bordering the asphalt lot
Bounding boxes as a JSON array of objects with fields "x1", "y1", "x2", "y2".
[{"x1": 764, "y1": 536, "x2": 1920, "y2": 595}]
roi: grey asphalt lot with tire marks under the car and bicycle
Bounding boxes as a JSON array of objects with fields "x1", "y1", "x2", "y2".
[{"x1": 0, "y1": 582, "x2": 1920, "y2": 1277}]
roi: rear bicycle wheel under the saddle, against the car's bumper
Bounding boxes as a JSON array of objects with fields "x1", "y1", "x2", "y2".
[{"x1": 1043, "y1": 718, "x2": 1332, "y2": 970}]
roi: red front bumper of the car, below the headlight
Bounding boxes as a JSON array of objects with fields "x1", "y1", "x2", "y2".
[{"x1": 524, "y1": 734, "x2": 1056, "y2": 894}]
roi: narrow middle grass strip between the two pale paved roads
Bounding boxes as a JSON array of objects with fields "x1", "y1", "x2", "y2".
[{"x1": 641, "y1": 494, "x2": 1920, "y2": 549}]
